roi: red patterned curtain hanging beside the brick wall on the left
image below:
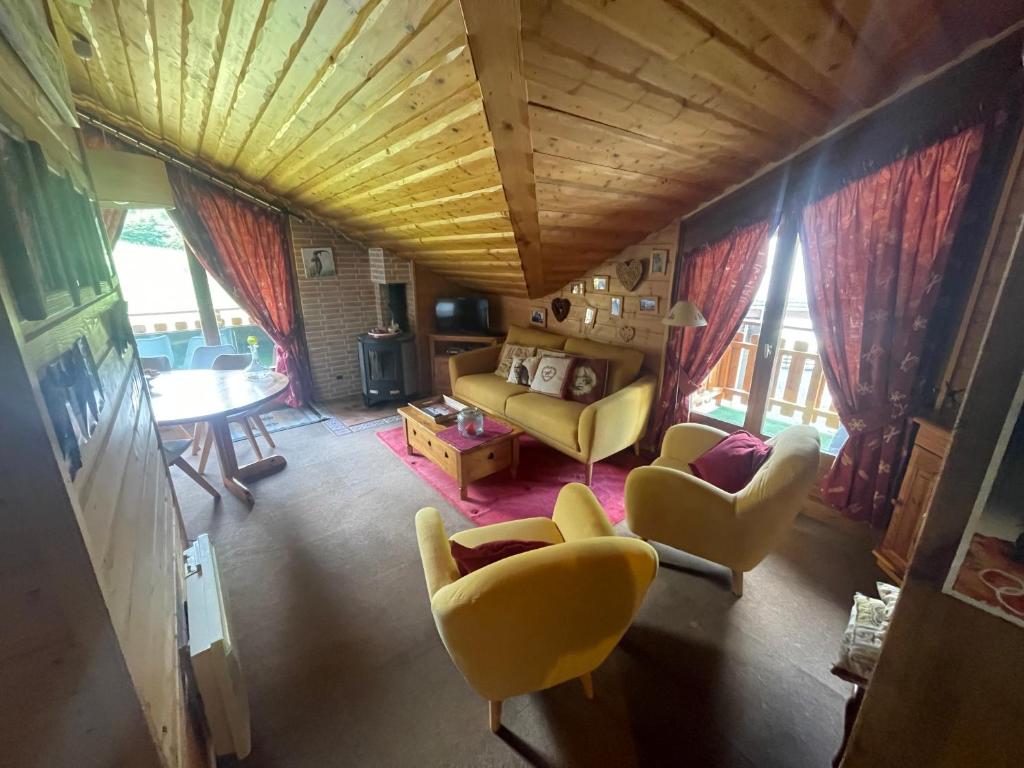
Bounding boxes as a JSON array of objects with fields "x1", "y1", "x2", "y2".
[{"x1": 167, "y1": 164, "x2": 310, "y2": 407}]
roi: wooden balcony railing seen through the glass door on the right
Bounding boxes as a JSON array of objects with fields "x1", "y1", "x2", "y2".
[{"x1": 693, "y1": 324, "x2": 840, "y2": 436}]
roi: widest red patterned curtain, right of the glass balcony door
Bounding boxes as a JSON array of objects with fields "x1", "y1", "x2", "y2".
[{"x1": 801, "y1": 126, "x2": 983, "y2": 526}]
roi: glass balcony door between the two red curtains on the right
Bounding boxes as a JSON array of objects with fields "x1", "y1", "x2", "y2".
[{"x1": 691, "y1": 227, "x2": 846, "y2": 454}]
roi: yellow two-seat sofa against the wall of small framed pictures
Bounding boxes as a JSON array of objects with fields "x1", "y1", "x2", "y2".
[{"x1": 449, "y1": 326, "x2": 655, "y2": 485}]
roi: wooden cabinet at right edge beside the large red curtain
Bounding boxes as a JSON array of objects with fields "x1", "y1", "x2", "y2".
[{"x1": 874, "y1": 419, "x2": 950, "y2": 586}]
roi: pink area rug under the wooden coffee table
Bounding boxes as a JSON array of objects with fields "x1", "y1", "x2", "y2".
[{"x1": 377, "y1": 427, "x2": 643, "y2": 525}]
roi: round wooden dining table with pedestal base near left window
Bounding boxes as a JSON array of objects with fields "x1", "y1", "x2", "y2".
[{"x1": 150, "y1": 370, "x2": 288, "y2": 507}]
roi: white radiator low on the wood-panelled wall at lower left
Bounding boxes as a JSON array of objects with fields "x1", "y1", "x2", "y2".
[{"x1": 185, "y1": 534, "x2": 250, "y2": 758}]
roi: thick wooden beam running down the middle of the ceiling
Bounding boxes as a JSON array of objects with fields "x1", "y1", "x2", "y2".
[{"x1": 460, "y1": 0, "x2": 546, "y2": 298}]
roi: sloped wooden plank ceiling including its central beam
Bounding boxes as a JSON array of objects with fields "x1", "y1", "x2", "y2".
[{"x1": 49, "y1": 0, "x2": 1022, "y2": 296}]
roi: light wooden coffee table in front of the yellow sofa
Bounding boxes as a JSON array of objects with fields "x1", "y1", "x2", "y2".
[{"x1": 398, "y1": 406, "x2": 523, "y2": 501}]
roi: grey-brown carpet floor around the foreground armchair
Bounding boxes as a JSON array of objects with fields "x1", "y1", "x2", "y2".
[{"x1": 172, "y1": 424, "x2": 880, "y2": 768}]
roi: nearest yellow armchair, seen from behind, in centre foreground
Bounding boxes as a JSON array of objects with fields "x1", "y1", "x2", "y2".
[{"x1": 416, "y1": 483, "x2": 657, "y2": 731}]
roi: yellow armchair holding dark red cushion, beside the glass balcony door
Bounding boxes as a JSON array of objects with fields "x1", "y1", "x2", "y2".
[{"x1": 626, "y1": 424, "x2": 819, "y2": 597}]
